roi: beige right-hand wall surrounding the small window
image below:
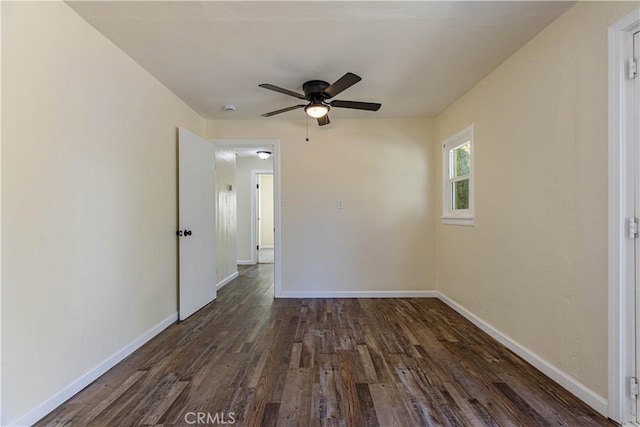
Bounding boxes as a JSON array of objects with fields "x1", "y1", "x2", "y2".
[{"x1": 435, "y1": 2, "x2": 637, "y2": 399}]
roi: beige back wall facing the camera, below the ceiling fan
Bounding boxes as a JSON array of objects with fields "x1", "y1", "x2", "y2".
[{"x1": 207, "y1": 119, "x2": 440, "y2": 292}]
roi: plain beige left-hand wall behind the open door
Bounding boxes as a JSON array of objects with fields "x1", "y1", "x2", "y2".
[{"x1": 1, "y1": 2, "x2": 204, "y2": 425}]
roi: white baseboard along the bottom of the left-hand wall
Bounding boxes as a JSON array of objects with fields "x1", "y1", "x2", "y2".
[{"x1": 9, "y1": 313, "x2": 178, "y2": 426}]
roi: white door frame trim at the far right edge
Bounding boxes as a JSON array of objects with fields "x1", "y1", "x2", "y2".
[{"x1": 607, "y1": 8, "x2": 640, "y2": 424}]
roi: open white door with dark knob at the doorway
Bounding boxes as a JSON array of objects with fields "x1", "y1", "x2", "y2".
[{"x1": 177, "y1": 128, "x2": 216, "y2": 320}]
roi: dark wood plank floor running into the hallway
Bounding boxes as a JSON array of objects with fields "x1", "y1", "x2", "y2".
[{"x1": 38, "y1": 264, "x2": 614, "y2": 427}]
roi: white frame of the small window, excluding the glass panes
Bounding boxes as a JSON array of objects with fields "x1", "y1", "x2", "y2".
[{"x1": 440, "y1": 125, "x2": 475, "y2": 225}]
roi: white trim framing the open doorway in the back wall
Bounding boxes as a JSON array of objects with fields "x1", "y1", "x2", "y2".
[{"x1": 210, "y1": 139, "x2": 282, "y2": 298}]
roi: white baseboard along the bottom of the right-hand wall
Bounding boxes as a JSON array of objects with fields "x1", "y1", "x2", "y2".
[{"x1": 436, "y1": 292, "x2": 608, "y2": 418}]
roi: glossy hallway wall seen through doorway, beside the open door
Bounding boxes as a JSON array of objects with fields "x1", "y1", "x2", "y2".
[{"x1": 215, "y1": 148, "x2": 238, "y2": 283}]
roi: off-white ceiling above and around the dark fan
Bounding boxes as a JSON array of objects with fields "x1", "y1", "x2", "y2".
[{"x1": 69, "y1": 1, "x2": 574, "y2": 120}]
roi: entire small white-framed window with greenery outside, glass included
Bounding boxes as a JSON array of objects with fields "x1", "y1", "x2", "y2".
[{"x1": 442, "y1": 125, "x2": 473, "y2": 225}]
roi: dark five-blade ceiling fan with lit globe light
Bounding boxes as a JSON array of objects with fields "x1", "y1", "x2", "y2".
[{"x1": 258, "y1": 73, "x2": 381, "y2": 126}]
